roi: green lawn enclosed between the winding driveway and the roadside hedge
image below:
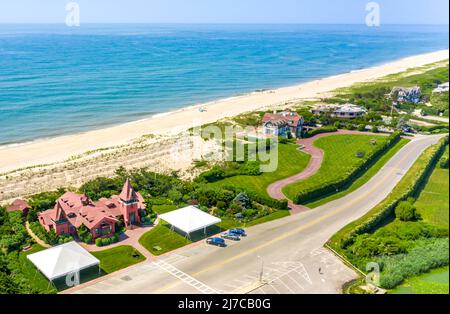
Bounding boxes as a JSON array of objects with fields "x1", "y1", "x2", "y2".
[{"x1": 283, "y1": 135, "x2": 387, "y2": 200}]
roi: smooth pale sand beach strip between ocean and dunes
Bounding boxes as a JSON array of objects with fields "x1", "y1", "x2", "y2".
[{"x1": 0, "y1": 50, "x2": 449, "y2": 173}]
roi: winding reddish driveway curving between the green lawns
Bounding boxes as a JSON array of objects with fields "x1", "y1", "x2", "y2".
[{"x1": 267, "y1": 130, "x2": 382, "y2": 215}]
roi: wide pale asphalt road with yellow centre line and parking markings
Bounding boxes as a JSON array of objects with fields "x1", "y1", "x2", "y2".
[{"x1": 71, "y1": 136, "x2": 439, "y2": 294}]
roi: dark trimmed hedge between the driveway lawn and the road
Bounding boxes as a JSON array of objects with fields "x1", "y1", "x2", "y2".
[{"x1": 294, "y1": 132, "x2": 401, "y2": 204}]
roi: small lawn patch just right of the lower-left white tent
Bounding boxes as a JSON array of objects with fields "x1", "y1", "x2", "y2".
[{"x1": 92, "y1": 245, "x2": 145, "y2": 274}]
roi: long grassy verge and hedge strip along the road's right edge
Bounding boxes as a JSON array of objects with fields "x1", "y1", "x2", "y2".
[{"x1": 328, "y1": 137, "x2": 448, "y2": 251}]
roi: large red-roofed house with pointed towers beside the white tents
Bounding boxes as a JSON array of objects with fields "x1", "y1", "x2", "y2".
[{"x1": 38, "y1": 179, "x2": 145, "y2": 239}]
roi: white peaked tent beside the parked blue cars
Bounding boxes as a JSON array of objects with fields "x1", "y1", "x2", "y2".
[{"x1": 159, "y1": 206, "x2": 222, "y2": 235}]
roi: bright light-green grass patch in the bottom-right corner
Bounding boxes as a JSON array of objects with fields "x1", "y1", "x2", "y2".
[{"x1": 389, "y1": 266, "x2": 449, "y2": 294}]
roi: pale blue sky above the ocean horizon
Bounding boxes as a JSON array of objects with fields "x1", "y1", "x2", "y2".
[{"x1": 0, "y1": 0, "x2": 449, "y2": 24}]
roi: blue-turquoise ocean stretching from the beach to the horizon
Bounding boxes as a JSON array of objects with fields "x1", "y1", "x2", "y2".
[{"x1": 0, "y1": 24, "x2": 449, "y2": 144}]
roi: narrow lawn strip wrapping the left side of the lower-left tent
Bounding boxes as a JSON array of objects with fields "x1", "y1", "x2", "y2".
[{"x1": 19, "y1": 244, "x2": 57, "y2": 294}]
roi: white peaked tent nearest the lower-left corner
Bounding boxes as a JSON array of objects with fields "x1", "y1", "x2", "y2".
[{"x1": 27, "y1": 242, "x2": 100, "y2": 281}]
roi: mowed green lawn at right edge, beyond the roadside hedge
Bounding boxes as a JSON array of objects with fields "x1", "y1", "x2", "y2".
[{"x1": 415, "y1": 147, "x2": 449, "y2": 228}]
